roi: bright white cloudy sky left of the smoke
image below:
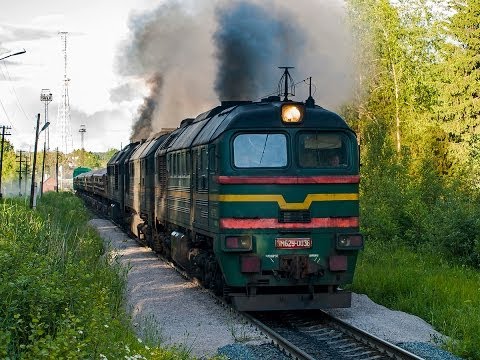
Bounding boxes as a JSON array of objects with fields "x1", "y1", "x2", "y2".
[{"x1": 0, "y1": 0, "x2": 165, "y2": 151}]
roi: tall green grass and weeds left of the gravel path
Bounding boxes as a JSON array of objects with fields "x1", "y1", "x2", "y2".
[{"x1": 0, "y1": 193, "x2": 204, "y2": 359}]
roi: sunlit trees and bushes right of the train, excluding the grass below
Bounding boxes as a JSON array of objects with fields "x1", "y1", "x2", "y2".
[{"x1": 343, "y1": 0, "x2": 480, "y2": 267}]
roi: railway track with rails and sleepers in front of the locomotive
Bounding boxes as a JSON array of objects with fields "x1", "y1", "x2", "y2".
[{"x1": 244, "y1": 310, "x2": 422, "y2": 360}]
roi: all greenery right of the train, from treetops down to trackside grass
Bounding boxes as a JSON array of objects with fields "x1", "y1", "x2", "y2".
[{"x1": 342, "y1": 0, "x2": 480, "y2": 358}]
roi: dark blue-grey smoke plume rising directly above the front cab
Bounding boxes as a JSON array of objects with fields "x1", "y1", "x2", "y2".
[{"x1": 214, "y1": 2, "x2": 304, "y2": 100}]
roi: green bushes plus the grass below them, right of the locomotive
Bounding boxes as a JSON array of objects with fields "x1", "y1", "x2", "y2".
[{"x1": 353, "y1": 130, "x2": 480, "y2": 359}]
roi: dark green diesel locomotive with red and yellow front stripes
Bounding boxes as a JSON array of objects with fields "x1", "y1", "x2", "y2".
[{"x1": 86, "y1": 97, "x2": 363, "y2": 310}]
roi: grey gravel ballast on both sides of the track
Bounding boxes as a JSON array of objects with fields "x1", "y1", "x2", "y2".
[{"x1": 90, "y1": 219, "x2": 462, "y2": 360}]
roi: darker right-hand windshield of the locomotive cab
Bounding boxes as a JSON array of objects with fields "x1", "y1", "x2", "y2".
[{"x1": 298, "y1": 132, "x2": 349, "y2": 168}]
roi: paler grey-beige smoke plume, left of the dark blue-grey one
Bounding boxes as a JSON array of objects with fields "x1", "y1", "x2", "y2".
[{"x1": 118, "y1": 0, "x2": 216, "y2": 140}]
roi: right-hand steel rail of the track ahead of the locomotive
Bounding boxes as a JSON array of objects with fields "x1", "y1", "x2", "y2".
[{"x1": 319, "y1": 310, "x2": 424, "y2": 360}]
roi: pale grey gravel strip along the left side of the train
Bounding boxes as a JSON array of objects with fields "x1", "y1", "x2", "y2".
[{"x1": 90, "y1": 219, "x2": 265, "y2": 357}]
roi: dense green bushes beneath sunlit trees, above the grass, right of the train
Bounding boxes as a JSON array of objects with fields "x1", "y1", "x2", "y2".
[{"x1": 360, "y1": 135, "x2": 480, "y2": 268}]
